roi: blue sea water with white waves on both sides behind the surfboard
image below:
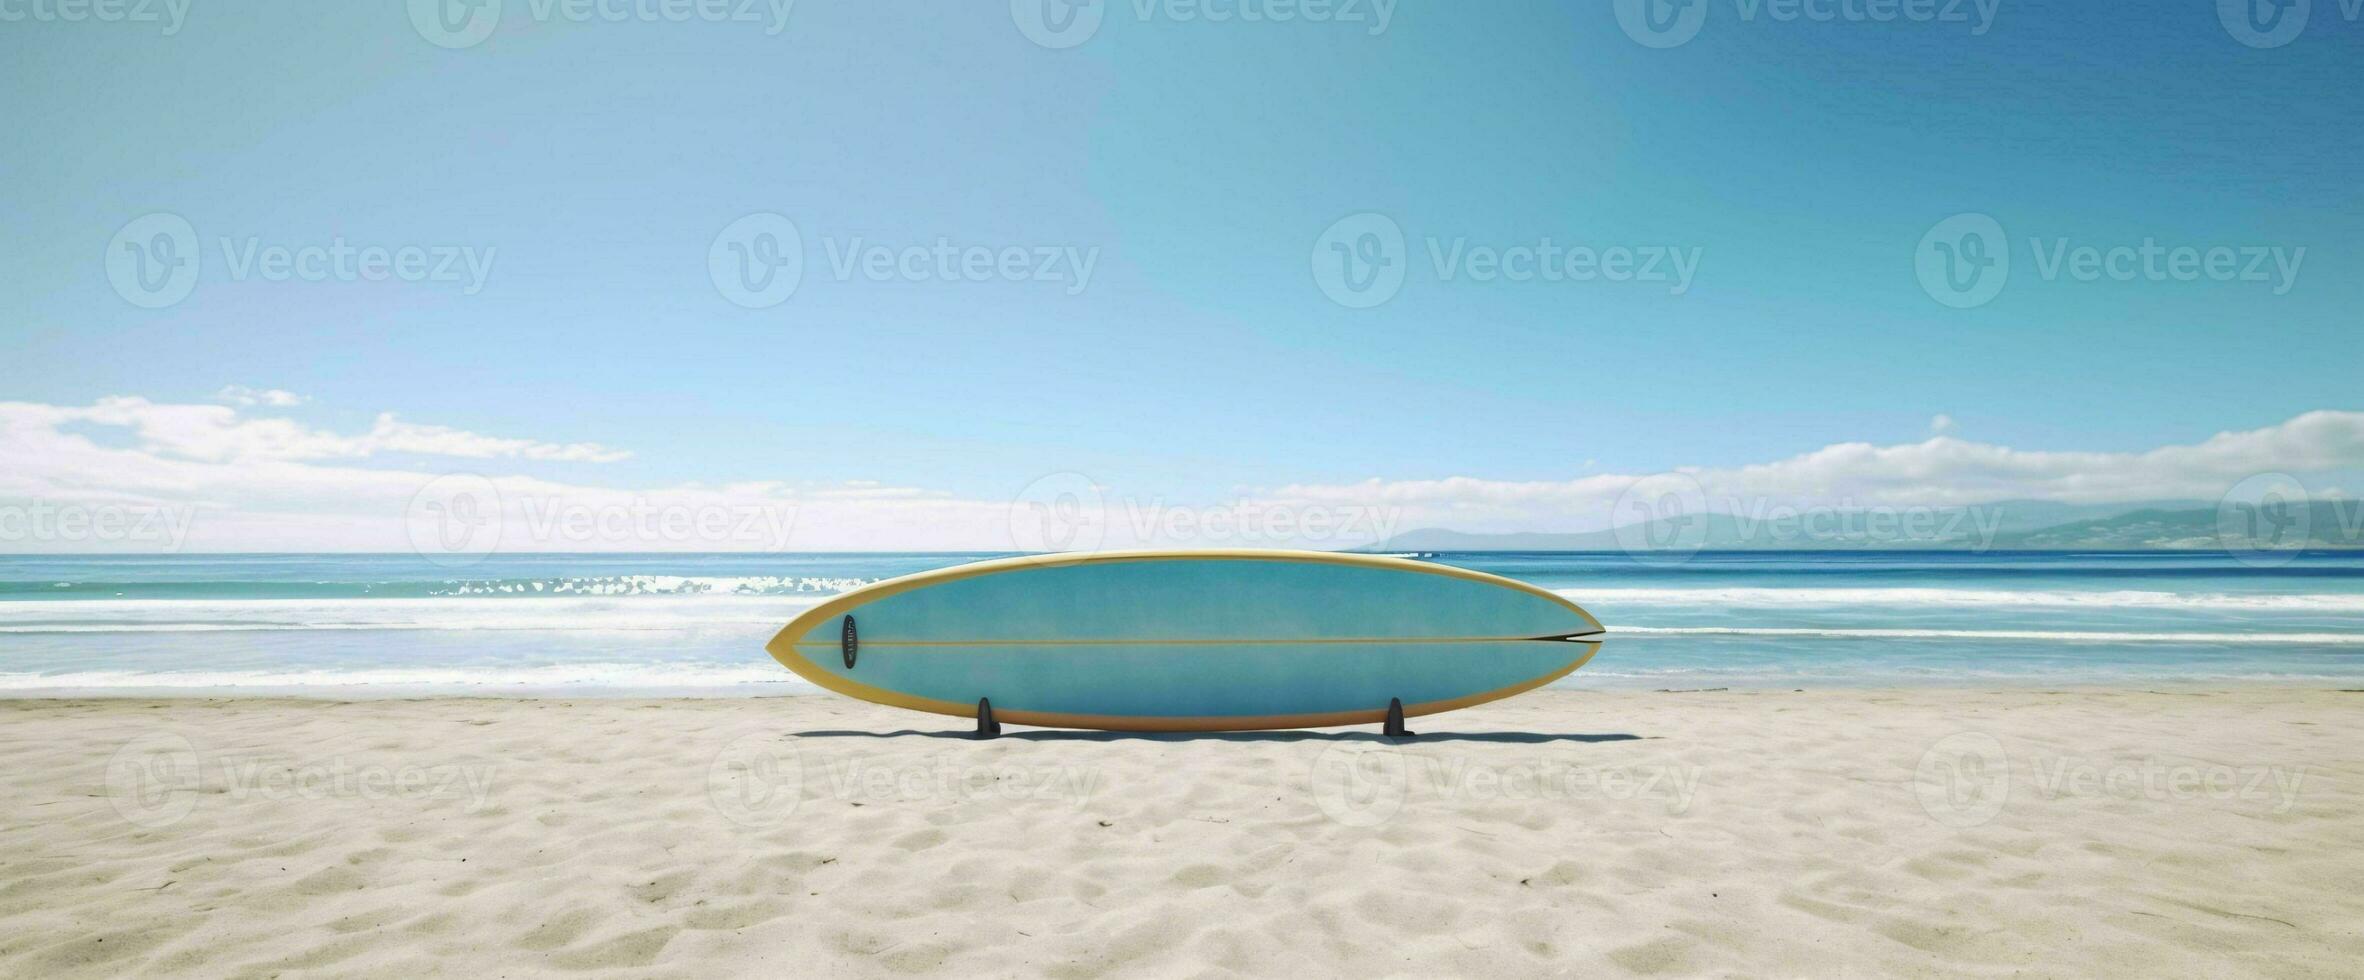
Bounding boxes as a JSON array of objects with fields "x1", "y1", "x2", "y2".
[{"x1": 0, "y1": 553, "x2": 2364, "y2": 697}]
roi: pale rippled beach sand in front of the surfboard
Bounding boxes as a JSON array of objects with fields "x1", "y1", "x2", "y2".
[{"x1": 0, "y1": 687, "x2": 2364, "y2": 978}]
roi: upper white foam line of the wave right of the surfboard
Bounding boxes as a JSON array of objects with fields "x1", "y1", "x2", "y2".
[{"x1": 1558, "y1": 588, "x2": 2364, "y2": 614}]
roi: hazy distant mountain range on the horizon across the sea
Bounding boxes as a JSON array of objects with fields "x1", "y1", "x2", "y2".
[{"x1": 1371, "y1": 501, "x2": 2364, "y2": 550}]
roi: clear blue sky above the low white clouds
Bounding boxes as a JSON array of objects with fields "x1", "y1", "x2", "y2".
[{"x1": 0, "y1": 0, "x2": 2364, "y2": 552}]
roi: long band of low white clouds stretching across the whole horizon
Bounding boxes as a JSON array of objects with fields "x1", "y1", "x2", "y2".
[{"x1": 0, "y1": 397, "x2": 2364, "y2": 553}]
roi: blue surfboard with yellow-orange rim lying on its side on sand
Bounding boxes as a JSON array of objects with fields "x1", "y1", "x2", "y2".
[{"x1": 766, "y1": 550, "x2": 1603, "y2": 732}]
